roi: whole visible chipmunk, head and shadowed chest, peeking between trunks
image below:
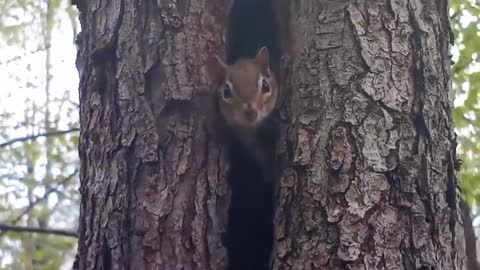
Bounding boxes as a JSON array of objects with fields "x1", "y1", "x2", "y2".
[{"x1": 215, "y1": 46, "x2": 279, "y2": 181}]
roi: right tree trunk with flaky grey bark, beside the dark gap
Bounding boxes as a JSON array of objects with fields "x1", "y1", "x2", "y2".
[{"x1": 273, "y1": 0, "x2": 466, "y2": 270}]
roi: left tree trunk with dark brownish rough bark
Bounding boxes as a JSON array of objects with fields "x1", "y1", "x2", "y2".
[{"x1": 76, "y1": 0, "x2": 228, "y2": 269}]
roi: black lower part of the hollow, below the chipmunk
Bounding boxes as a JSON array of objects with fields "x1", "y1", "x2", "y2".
[{"x1": 225, "y1": 137, "x2": 274, "y2": 270}]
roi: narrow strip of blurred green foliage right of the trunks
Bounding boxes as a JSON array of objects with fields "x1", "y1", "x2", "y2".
[{"x1": 450, "y1": 0, "x2": 480, "y2": 206}]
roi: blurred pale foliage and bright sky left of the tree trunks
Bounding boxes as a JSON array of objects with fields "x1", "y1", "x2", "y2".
[{"x1": 0, "y1": 0, "x2": 79, "y2": 270}]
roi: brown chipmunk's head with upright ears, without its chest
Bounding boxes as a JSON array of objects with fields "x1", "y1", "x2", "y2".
[{"x1": 210, "y1": 47, "x2": 279, "y2": 128}]
